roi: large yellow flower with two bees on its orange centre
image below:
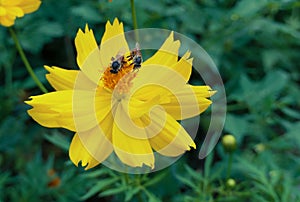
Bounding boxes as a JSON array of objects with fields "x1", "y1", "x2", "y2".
[{"x1": 26, "y1": 19, "x2": 214, "y2": 169}]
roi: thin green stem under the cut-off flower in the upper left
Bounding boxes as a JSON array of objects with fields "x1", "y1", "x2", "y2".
[{"x1": 8, "y1": 27, "x2": 48, "y2": 93}]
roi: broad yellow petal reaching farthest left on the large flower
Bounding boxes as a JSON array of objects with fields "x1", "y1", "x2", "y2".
[{"x1": 25, "y1": 89, "x2": 111, "y2": 132}]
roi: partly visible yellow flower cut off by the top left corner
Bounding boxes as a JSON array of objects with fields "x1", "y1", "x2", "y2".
[{"x1": 0, "y1": 0, "x2": 41, "y2": 27}]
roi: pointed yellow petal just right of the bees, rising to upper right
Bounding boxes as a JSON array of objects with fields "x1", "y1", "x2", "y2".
[{"x1": 143, "y1": 32, "x2": 180, "y2": 68}]
